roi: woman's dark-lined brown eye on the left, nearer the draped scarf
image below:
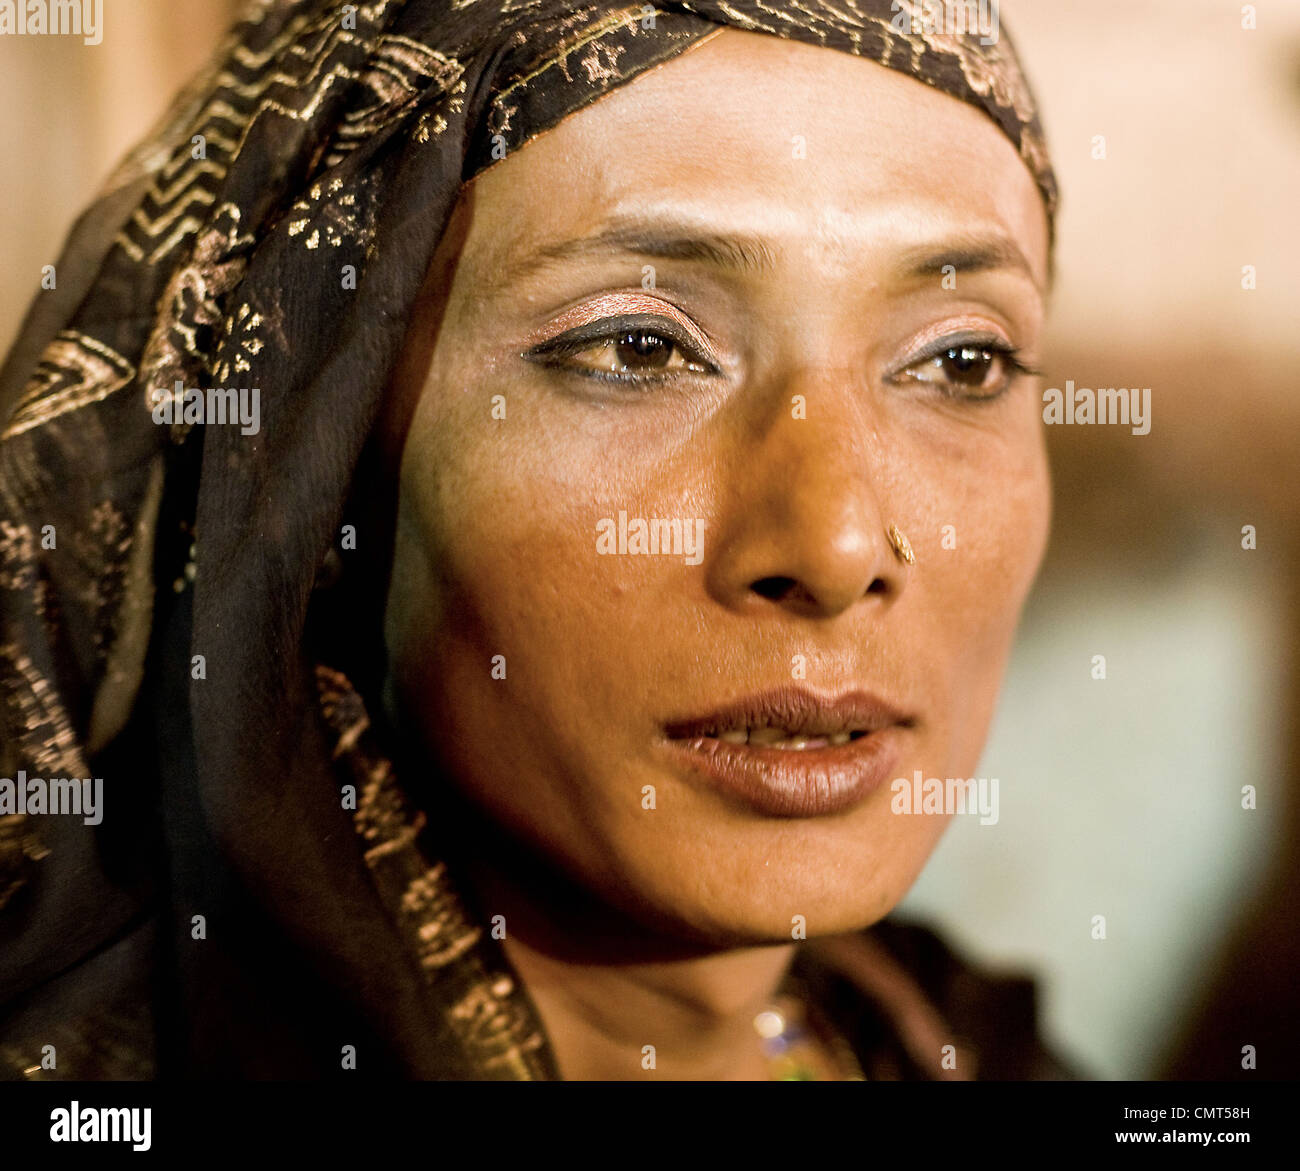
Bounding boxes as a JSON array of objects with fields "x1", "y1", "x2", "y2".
[{"x1": 524, "y1": 315, "x2": 718, "y2": 382}]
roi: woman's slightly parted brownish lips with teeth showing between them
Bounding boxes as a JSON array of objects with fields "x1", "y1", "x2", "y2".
[{"x1": 664, "y1": 688, "x2": 915, "y2": 817}]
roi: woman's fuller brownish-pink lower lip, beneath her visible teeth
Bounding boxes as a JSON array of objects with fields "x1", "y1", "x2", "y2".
[{"x1": 664, "y1": 724, "x2": 907, "y2": 817}]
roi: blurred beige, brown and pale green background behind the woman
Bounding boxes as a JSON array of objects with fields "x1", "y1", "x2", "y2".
[{"x1": 0, "y1": 0, "x2": 1300, "y2": 1079}]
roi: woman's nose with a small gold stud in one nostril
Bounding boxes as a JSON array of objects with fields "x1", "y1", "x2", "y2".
[{"x1": 707, "y1": 376, "x2": 907, "y2": 617}]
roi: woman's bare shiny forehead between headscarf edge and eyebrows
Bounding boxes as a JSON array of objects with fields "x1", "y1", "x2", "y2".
[{"x1": 469, "y1": 30, "x2": 1047, "y2": 292}]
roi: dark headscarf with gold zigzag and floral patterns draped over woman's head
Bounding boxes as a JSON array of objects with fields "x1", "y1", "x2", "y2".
[{"x1": 0, "y1": 0, "x2": 1056, "y2": 1077}]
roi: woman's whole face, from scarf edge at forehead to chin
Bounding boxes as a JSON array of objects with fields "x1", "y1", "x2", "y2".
[{"x1": 386, "y1": 30, "x2": 1049, "y2": 944}]
